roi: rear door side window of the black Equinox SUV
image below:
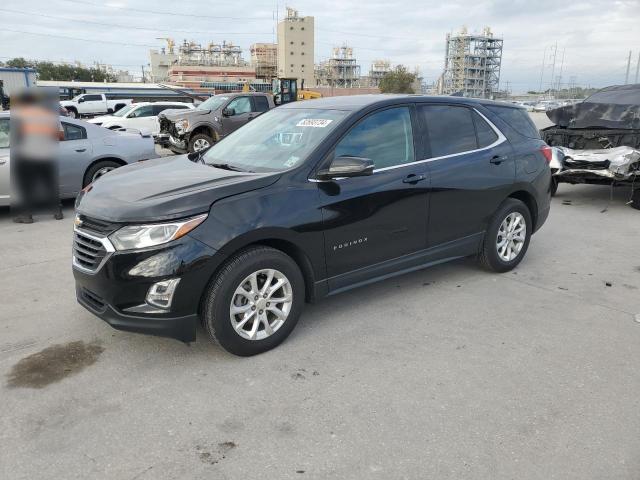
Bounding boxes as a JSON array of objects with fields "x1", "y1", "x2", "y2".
[{"x1": 419, "y1": 105, "x2": 478, "y2": 157}]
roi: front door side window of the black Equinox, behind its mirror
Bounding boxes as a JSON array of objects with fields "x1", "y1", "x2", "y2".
[{"x1": 335, "y1": 107, "x2": 414, "y2": 169}]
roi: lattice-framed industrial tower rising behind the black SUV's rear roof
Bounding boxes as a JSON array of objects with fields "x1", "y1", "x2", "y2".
[{"x1": 439, "y1": 27, "x2": 503, "y2": 98}]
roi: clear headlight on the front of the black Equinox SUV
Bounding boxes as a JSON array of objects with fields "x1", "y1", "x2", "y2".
[{"x1": 109, "y1": 214, "x2": 207, "y2": 250}]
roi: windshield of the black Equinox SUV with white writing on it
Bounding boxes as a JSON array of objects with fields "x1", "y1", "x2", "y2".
[{"x1": 204, "y1": 108, "x2": 349, "y2": 172}]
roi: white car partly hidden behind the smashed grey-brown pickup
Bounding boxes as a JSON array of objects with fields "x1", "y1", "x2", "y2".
[{"x1": 88, "y1": 102, "x2": 195, "y2": 135}]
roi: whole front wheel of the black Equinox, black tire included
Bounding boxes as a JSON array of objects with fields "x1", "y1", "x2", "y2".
[{"x1": 201, "y1": 247, "x2": 305, "y2": 357}]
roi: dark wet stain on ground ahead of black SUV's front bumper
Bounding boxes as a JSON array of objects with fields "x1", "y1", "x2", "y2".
[{"x1": 7, "y1": 341, "x2": 104, "y2": 388}]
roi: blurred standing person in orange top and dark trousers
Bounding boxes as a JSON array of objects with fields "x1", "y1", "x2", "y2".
[{"x1": 10, "y1": 88, "x2": 63, "y2": 223}]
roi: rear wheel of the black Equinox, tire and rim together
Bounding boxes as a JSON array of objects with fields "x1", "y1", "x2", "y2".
[{"x1": 479, "y1": 198, "x2": 533, "y2": 273}]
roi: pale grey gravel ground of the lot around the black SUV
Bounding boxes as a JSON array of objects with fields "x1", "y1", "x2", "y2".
[{"x1": 0, "y1": 109, "x2": 640, "y2": 480}]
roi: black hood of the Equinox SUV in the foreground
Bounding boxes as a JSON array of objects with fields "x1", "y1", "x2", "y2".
[{"x1": 77, "y1": 155, "x2": 280, "y2": 223}]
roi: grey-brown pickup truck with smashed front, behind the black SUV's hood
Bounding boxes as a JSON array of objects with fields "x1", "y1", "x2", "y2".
[{"x1": 156, "y1": 92, "x2": 275, "y2": 153}]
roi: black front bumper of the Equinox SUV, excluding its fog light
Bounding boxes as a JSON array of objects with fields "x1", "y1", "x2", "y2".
[{"x1": 73, "y1": 235, "x2": 217, "y2": 342}]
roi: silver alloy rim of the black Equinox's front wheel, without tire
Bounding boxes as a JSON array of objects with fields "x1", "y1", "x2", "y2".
[{"x1": 229, "y1": 269, "x2": 293, "y2": 340}]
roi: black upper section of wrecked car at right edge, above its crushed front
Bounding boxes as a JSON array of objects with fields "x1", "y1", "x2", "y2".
[{"x1": 547, "y1": 84, "x2": 640, "y2": 130}]
